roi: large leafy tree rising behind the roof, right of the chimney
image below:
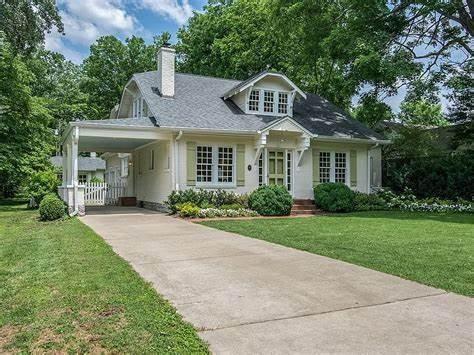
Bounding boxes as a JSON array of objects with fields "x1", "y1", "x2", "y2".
[{"x1": 177, "y1": 0, "x2": 421, "y2": 109}]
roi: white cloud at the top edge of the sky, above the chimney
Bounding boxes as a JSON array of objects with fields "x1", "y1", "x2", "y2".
[{"x1": 136, "y1": 0, "x2": 193, "y2": 25}]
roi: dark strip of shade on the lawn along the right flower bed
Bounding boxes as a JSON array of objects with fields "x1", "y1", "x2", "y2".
[{"x1": 325, "y1": 211, "x2": 474, "y2": 224}]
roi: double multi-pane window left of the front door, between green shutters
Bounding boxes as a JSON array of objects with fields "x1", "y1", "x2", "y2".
[{"x1": 196, "y1": 145, "x2": 235, "y2": 185}]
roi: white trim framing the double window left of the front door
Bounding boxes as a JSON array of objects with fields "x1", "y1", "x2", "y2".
[{"x1": 195, "y1": 143, "x2": 237, "y2": 189}]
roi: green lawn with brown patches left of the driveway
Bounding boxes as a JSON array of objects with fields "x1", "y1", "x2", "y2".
[{"x1": 0, "y1": 200, "x2": 208, "y2": 354}]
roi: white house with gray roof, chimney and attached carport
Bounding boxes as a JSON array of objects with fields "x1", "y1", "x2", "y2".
[{"x1": 61, "y1": 47, "x2": 388, "y2": 213}]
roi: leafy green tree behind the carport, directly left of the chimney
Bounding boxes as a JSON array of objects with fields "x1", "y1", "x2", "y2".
[{"x1": 81, "y1": 36, "x2": 159, "y2": 119}]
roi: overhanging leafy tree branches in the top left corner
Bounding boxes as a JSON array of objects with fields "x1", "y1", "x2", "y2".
[{"x1": 0, "y1": 0, "x2": 64, "y2": 54}]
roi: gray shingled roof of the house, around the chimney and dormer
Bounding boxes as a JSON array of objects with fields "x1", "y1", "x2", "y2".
[{"x1": 78, "y1": 71, "x2": 383, "y2": 139}]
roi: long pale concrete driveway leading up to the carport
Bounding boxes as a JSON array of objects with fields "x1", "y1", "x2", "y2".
[{"x1": 81, "y1": 208, "x2": 474, "y2": 354}]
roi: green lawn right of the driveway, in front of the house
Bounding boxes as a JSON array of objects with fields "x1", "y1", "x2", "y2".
[{"x1": 203, "y1": 212, "x2": 474, "y2": 297}]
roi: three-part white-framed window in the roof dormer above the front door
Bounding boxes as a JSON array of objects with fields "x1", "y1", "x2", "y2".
[{"x1": 247, "y1": 89, "x2": 290, "y2": 116}]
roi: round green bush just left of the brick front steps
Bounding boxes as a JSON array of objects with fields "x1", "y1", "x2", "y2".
[{"x1": 249, "y1": 185, "x2": 293, "y2": 216}]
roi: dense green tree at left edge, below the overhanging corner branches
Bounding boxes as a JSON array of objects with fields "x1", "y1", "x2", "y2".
[{"x1": 0, "y1": 41, "x2": 53, "y2": 196}]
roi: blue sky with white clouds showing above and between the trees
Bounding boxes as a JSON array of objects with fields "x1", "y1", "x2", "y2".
[{"x1": 46, "y1": 0, "x2": 452, "y2": 112}]
